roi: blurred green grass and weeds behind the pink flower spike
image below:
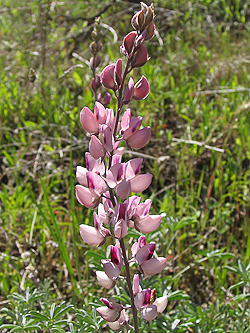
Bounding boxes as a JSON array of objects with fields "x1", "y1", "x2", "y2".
[{"x1": 0, "y1": 0, "x2": 250, "y2": 332}]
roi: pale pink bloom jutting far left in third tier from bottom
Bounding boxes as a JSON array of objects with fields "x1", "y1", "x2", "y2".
[{"x1": 79, "y1": 213, "x2": 110, "y2": 246}]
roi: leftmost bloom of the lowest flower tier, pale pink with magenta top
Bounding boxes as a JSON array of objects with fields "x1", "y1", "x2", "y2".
[{"x1": 96, "y1": 298, "x2": 122, "y2": 322}]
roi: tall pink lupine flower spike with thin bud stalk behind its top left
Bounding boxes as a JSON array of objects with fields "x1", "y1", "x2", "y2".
[{"x1": 76, "y1": 3, "x2": 167, "y2": 333}]
